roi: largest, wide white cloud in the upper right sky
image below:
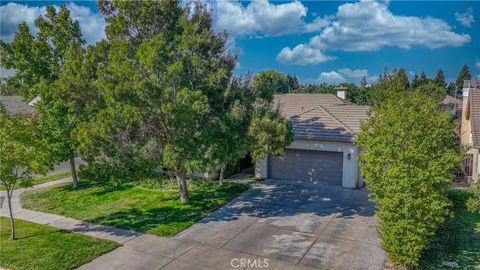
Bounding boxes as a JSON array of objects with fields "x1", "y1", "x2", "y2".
[{"x1": 277, "y1": 1, "x2": 471, "y2": 64}]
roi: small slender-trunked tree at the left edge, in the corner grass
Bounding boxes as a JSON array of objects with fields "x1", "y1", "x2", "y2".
[{"x1": 0, "y1": 106, "x2": 46, "y2": 239}]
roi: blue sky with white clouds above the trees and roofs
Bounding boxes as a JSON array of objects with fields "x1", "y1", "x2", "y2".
[{"x1": 0, "y1": 0, "x2": 480, "y2": 83}]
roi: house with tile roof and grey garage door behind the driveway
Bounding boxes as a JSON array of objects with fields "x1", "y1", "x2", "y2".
[{"x1": 255, "y1": 88, "x2": 368, "y2": 188}]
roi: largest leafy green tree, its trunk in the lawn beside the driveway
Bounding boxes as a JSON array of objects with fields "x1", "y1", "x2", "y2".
[{"x1": 76, "y1": 1, "x2": 236, "y2": 202}]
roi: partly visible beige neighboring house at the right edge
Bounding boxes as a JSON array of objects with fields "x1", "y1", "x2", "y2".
[{"x1": 461, "y1": 80, "x2": 480, "y2": 182}]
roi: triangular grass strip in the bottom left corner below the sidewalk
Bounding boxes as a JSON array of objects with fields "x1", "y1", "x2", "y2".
[{"x1": 0, "y1": 217, "x2": 118, "y2": 270}]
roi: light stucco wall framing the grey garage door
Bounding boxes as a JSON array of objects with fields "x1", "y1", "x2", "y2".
[{"x1": 255, "y1": 139, "x2": 363, "y2": 188}]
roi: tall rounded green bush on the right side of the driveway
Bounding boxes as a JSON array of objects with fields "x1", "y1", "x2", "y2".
[{"x1": 357, "y1": 84, "x2": 461, "y2": 267}]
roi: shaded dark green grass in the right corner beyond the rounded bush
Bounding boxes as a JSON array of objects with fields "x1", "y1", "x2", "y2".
[{"x1": 419, "y1": 190, "x2": 480, "y2": 269}]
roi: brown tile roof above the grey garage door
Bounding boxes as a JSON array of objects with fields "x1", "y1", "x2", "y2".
[{"x1": 274, "y1": 93, "x2": 368, "y2": 141}]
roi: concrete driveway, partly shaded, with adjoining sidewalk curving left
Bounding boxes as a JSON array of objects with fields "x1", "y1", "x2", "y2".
[{"x1": 0, "y1": 178, "x2": 385, "y2": 270}]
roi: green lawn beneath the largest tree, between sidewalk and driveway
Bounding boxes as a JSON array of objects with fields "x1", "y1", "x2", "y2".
[{"x1": 22, "y1": 180, "x2": 248, "y2": 236}]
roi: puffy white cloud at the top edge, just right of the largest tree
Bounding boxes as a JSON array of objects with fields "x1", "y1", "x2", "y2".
[{"x1": 215, "y1": 0, "x2": 307, "y2": 36}]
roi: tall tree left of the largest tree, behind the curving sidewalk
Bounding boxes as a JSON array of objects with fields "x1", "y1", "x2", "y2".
[{"x1": 0, "y1": 5, "x2": 85, "y2": 188}]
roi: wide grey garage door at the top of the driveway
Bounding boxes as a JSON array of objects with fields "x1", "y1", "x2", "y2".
[{"x1": 268, "y1": 149, "x2": 343, "y2": 186}]
